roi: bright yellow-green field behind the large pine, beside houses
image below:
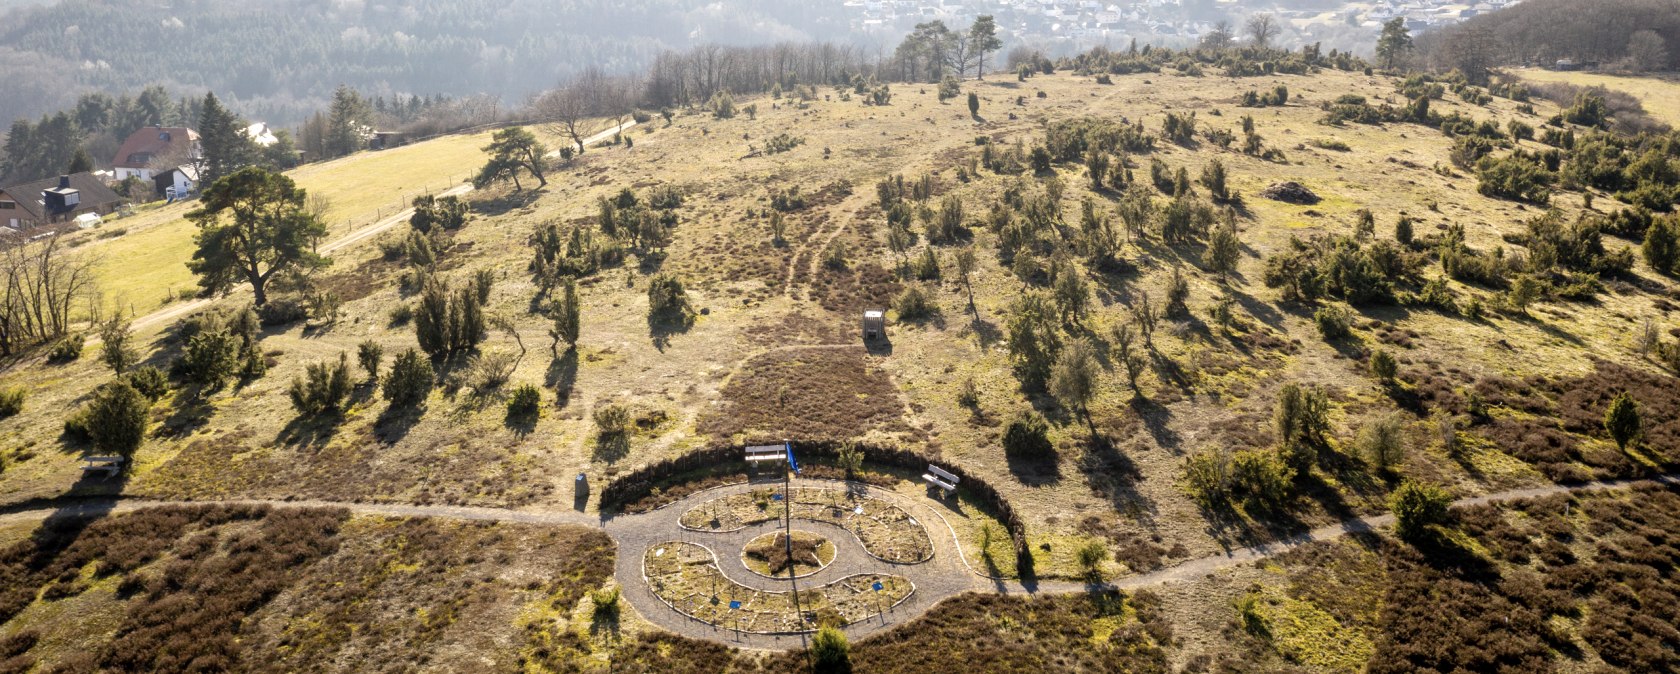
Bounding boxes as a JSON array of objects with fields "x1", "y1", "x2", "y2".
[{"x1": 72, "y1": 133, "x2": 489, "y2": 314}]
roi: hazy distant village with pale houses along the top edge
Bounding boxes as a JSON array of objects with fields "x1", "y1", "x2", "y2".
[{"x1": 845, "y1": 0, "x2": 1520, "y2": 47}]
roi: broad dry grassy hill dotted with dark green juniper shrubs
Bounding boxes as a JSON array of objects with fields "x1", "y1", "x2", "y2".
[{"x1": 0, "y1": 52, "x2": 1680, "y2": 667}]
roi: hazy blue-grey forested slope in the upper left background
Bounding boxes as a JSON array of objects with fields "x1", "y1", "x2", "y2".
[{"x1": 0, "y1": 0, "x2": 843, "y2": 124}]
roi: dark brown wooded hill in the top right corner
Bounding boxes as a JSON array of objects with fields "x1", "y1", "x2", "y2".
[{"x1": 1418, "y1": 0, "x2": 1680, "y2": 74}]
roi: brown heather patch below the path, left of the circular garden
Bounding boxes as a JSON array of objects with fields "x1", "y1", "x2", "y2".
[{"x1": 0, "y1": 506, "x2": 613, "y2": 672}]
